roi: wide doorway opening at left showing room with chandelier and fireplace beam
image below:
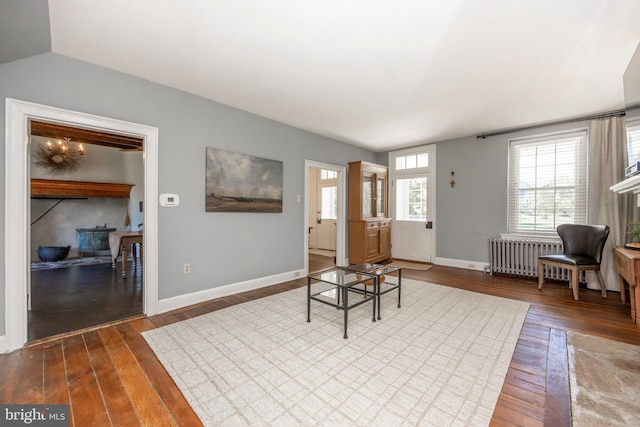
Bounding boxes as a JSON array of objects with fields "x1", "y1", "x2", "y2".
[{"x1": 27, "y1": 120, "x2": 144, "y2": 341}]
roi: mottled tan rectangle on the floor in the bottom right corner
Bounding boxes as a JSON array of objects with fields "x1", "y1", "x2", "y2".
[{"x1": 567, "y1": 332, "x2": 640, "y2": 427}]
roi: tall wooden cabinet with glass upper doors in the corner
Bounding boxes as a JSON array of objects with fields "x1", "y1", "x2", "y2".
[{"x1": 349, "y1": 162, "x2": 391, "y2": 264}]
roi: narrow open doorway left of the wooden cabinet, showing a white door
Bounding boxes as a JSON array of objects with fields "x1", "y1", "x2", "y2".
[{"x1": 304, "y1": 160, "x2": 346, "y2": 273}]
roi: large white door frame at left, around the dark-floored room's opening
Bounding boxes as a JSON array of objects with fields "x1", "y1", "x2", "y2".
[{"x1": 4, "y1": 98, "x2": 158, "y2": 351}]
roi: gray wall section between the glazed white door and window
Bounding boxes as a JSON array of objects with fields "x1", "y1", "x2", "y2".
[{"x1": 436, "y1": 121, "x2": 588, "y2": 262}]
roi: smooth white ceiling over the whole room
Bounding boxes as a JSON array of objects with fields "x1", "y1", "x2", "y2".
[{"x1": 49, "y1": 0, "x2": 640, "y2": 152}]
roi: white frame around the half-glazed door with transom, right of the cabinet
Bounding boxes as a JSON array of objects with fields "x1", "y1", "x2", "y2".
[{"x1": 389, "y1": 144, "x2": 437, "y2": 263}]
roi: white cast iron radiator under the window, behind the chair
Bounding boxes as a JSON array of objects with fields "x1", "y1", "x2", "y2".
[{"x1": 489, "y1": 238, "x2": 584, "y2": 282}]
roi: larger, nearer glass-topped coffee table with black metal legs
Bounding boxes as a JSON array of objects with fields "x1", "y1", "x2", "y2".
[{"x1": 307, "y1": 267, "x2": 377, "y2": 339}]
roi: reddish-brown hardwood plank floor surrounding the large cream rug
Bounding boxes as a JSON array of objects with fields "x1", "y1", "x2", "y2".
[{"x1": 0, "y1": 266, "x2": 640, "y2": 426}]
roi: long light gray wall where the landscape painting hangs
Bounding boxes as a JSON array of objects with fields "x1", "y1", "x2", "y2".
[{"x1": 0, "y1": 53, "x2": 375, "y2": 333}]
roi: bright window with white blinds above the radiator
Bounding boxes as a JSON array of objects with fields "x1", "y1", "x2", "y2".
[{"x1": 508, "y1": 130, "x2": 587, "y2": 236}]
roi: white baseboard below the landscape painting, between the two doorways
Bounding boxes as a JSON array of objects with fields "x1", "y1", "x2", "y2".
[{"x1": 158, "y1": 270, "x2": 304, "y2": 314}]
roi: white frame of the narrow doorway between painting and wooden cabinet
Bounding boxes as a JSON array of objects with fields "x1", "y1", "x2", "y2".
[{"x1": 302, "y1": 160, "x2": 347, "y2": 275}]
